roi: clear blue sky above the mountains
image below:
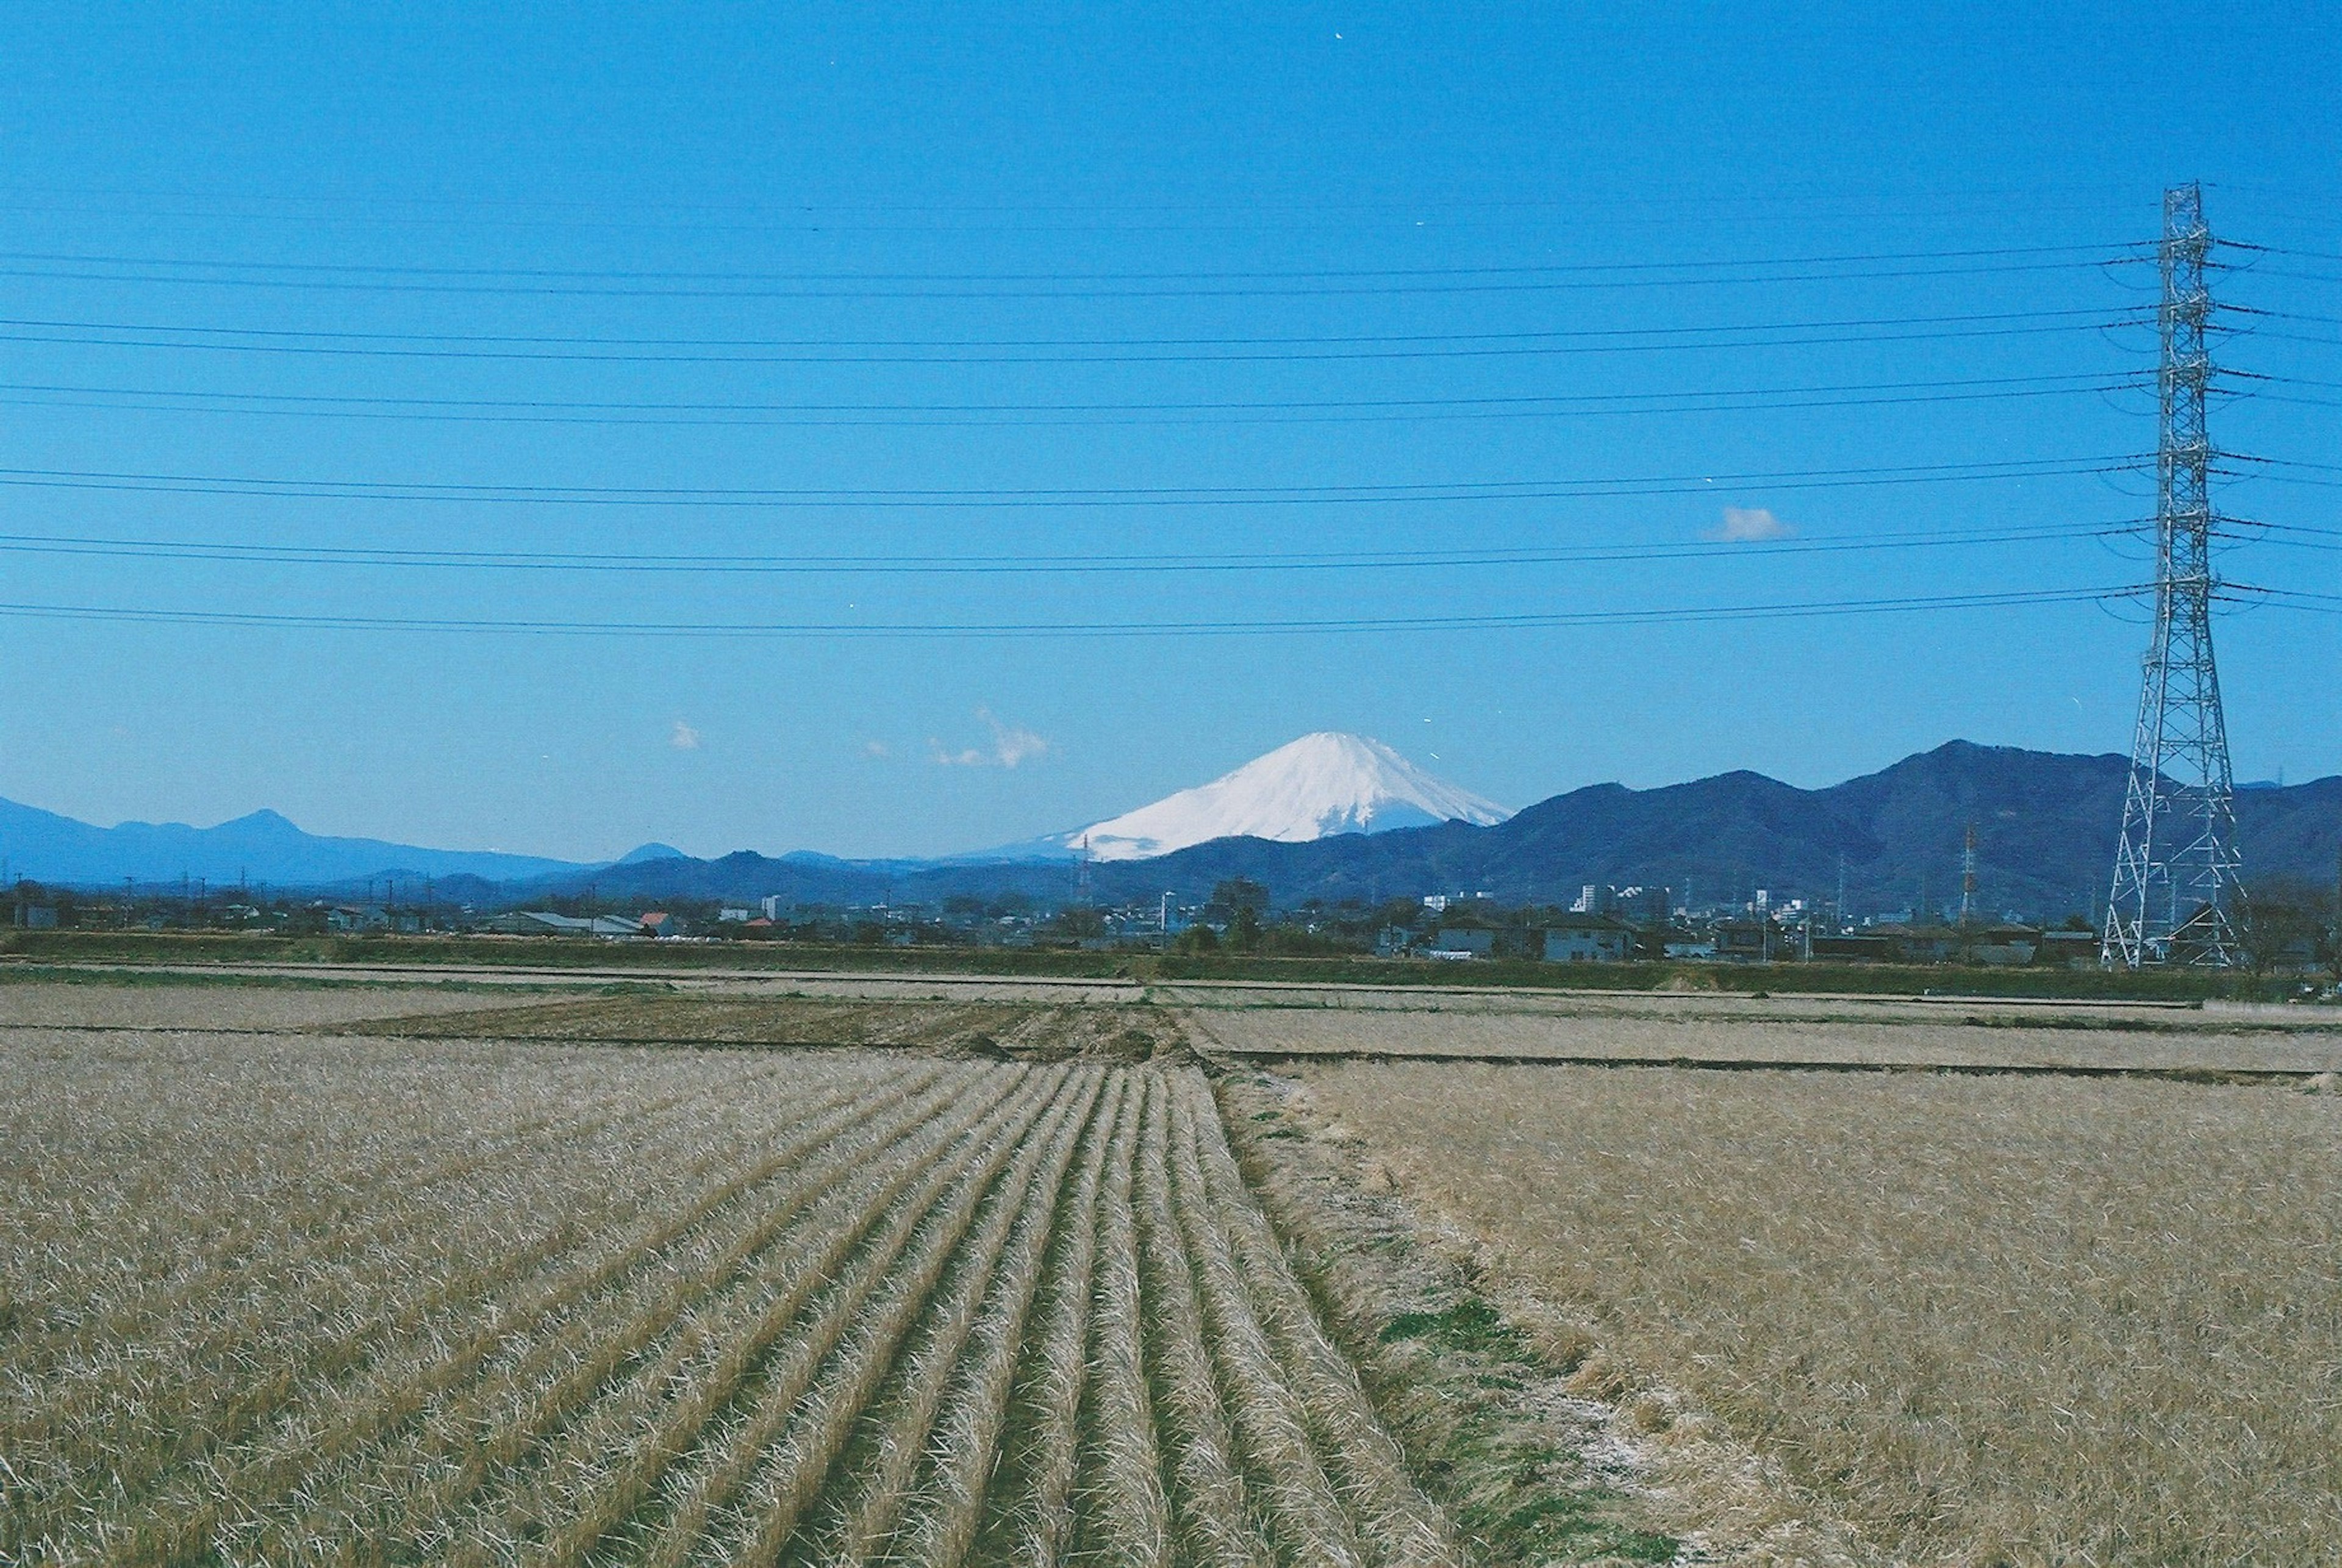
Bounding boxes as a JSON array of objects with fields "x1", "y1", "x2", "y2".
[{"x1": 0, "y1": 2, "x2": 2342, "y2": 856}]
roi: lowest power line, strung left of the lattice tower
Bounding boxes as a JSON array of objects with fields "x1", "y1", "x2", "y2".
[{"x1": 0, "y1": 587, "x2": 2143, "y2": 639}]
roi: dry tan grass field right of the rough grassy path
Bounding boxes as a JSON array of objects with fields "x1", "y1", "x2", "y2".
[{"x1": 1300, "y1": 1062, "x2": 2342, "y2": 1563}]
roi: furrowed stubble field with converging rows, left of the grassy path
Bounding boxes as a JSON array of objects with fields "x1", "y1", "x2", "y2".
[{"x1": 0, "y1": 1034, "x2": 1464, "y2": 1568}]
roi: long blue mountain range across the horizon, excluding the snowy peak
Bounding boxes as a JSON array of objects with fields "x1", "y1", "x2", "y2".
[{"x1": 0, "y1": 742, "x2": 2342, "y2": 917}]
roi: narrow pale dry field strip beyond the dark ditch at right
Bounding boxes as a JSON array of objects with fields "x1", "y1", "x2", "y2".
[{"x1": 1192, "y1": 1009, "x2": 2342, "y2": 1074}]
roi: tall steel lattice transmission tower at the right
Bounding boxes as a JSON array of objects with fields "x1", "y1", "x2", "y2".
[{"x1": 2099, "y1": 185, "x2": 2239, "y2": 969}]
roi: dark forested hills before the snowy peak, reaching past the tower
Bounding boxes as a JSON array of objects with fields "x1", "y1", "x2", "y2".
[{"x1": 543, "y1": 742, "x2": 2342, "y2": 917}]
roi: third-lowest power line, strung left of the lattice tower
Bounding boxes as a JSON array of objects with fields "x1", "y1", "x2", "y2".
[{"x1": 0, "y1": 454, "x2": 2147, "y2": 510}]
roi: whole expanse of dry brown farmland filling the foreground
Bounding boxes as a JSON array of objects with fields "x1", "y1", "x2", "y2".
[{"x1": 23, "y1": 973, "x2": 2342, "y2": 1568}]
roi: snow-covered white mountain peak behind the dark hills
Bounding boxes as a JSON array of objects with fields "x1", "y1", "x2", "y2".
[{"x1": 1059, "y1": 730, "x2": 1511, "y2": 861}]
